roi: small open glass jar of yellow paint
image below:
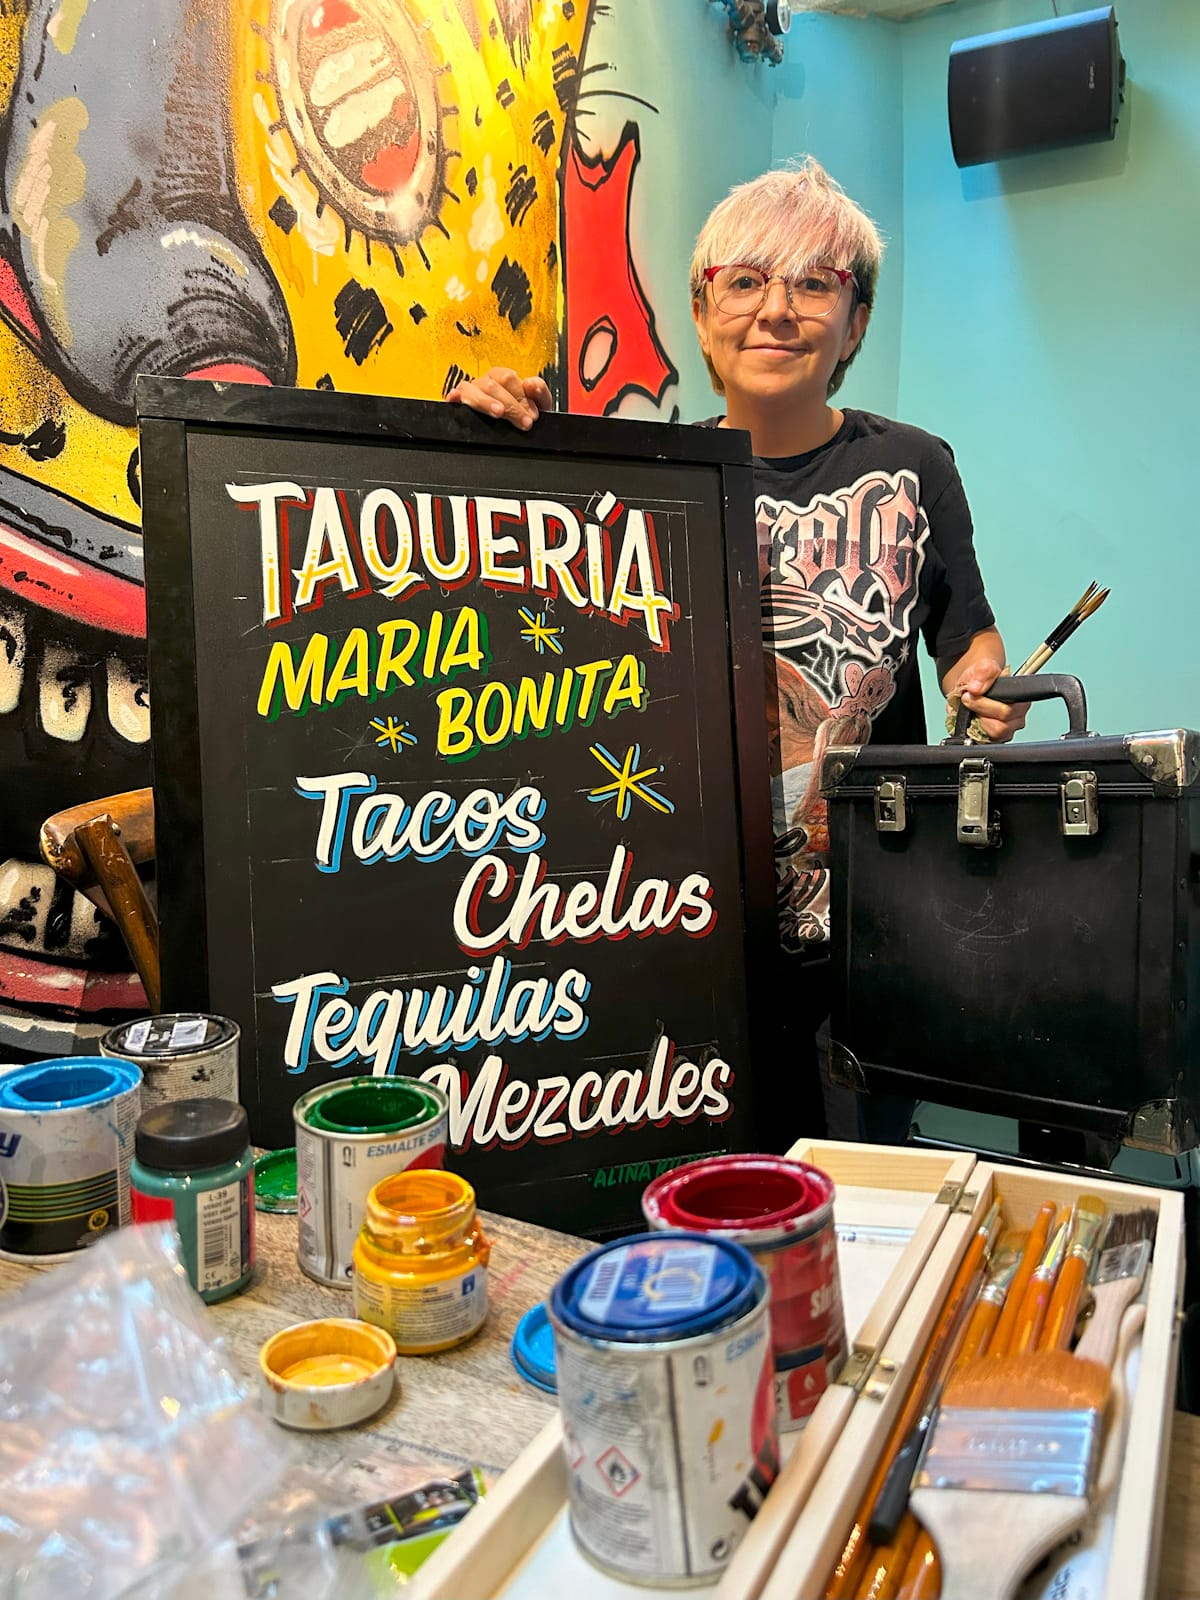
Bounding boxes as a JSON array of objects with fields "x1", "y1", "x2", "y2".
[{"x1": 354, "y1": 1168, "x2": 491, "y2": 1355}]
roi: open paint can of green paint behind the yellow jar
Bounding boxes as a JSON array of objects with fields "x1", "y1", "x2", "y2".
[{"x1": 293, "y1": 1077, "x2": 450, "y2": 1288}]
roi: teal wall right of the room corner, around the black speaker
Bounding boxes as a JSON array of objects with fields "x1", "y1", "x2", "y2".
[{"x1": 896, "y1": 0, "x2": 1200, "y2": 734}]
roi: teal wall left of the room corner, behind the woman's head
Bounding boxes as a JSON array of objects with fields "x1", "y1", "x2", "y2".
[{"x1": 581, "y1": 0, "x2": 904, "y2": 421}]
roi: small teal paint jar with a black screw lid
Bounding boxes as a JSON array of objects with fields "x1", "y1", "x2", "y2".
[{"x1": 130, "y1": 1099, "x2": 254, "y2": 1304}]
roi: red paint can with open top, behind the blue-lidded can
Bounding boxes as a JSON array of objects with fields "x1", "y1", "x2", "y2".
[{"x1": 642, "y1": 1155, "x2": 846, "y2": 1429}]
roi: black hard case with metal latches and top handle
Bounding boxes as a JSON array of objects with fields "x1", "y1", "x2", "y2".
[{"x1": 821, "y1": 674, "x2": 1200, "y2": 1166}]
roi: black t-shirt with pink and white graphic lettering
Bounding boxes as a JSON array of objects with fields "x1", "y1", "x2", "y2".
[{"x1": 704, "y1": 411, "x2": 994, "y2": 952}]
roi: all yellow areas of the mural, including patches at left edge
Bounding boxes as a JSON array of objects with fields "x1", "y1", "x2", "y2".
[{"x1": 0, "y1": 0, "x2": 590, "y2": 525}]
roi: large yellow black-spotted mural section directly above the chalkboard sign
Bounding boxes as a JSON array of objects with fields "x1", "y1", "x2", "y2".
[{"x1": 234, "y1": 0, "x2": 587, "y2": 397}]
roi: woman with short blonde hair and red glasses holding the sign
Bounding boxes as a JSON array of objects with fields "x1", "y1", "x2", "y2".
[{"x1": 448, "y1": 158, "x2": 1027, "y2": 1139}]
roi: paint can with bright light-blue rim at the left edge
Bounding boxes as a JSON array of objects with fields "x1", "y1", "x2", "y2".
[{"x1": 0, "y1": 1056, "x2": 142, "y2": 1261}]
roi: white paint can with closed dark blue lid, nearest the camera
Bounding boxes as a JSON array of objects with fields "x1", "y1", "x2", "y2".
[{"x1": 550, "y1": 1234, "x2": 779, "y2": 1587}]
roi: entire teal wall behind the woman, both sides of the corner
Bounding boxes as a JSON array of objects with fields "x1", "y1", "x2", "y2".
[{"x1": 598, "y1": 0, "x2": 1200, "y2": 734}]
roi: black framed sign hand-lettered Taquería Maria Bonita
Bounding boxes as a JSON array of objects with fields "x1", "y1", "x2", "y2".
[{"x1": 138, "y1": 379, "x2": 776, "y2": 1232}]
